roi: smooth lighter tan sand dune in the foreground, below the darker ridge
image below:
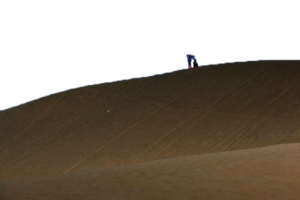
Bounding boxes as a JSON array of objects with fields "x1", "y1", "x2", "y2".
[{"x1": 0, "y1": 144, "x2": 300, "y2": 200}]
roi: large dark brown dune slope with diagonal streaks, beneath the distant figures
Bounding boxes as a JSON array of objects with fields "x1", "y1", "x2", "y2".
[{"x1": 0, "y1": 61, "x2": 300, "y2": 180}]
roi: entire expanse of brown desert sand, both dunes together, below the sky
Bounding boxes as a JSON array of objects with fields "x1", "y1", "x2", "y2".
[{"x1": 0, "y1": 61, "x2": 300, "y2": 200}]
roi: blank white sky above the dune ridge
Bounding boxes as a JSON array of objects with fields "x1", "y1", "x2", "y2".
[{"x1": 0, "y1": 0, "x2": 300, "y2": 110}]
